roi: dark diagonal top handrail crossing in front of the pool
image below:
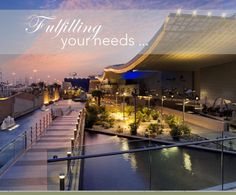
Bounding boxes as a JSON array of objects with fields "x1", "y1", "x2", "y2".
[{"x1": 47, "y1": 137, "x2": 236, "y2": 163}]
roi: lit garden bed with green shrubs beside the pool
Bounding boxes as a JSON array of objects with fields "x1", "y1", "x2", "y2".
[{"x1": 86, "y1": 92, "x2": 203, "y2": 141}]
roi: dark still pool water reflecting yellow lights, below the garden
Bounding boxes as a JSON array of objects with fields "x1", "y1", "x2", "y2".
[{"x1": 82, "y1": 132, "x2": 236, "y2": 190}]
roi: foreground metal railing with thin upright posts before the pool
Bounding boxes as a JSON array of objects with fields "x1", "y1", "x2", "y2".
[{"x1": 48, "y1": 133, "x2": 236, "y2": 190}]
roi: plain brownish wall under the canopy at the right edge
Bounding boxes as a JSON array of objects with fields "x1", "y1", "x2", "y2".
[{"x1": 200, "y1": 63, "x2": 236, "y2": 105}]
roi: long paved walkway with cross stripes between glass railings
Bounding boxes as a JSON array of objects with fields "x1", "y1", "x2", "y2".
[{"x1": 0, "y1": 112, "x2": 78, "y2": 191}]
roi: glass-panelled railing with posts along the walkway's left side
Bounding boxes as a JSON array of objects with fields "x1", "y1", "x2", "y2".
[{"x1": 0, "y1": 112, "x2": 52, "y2": 175}]
